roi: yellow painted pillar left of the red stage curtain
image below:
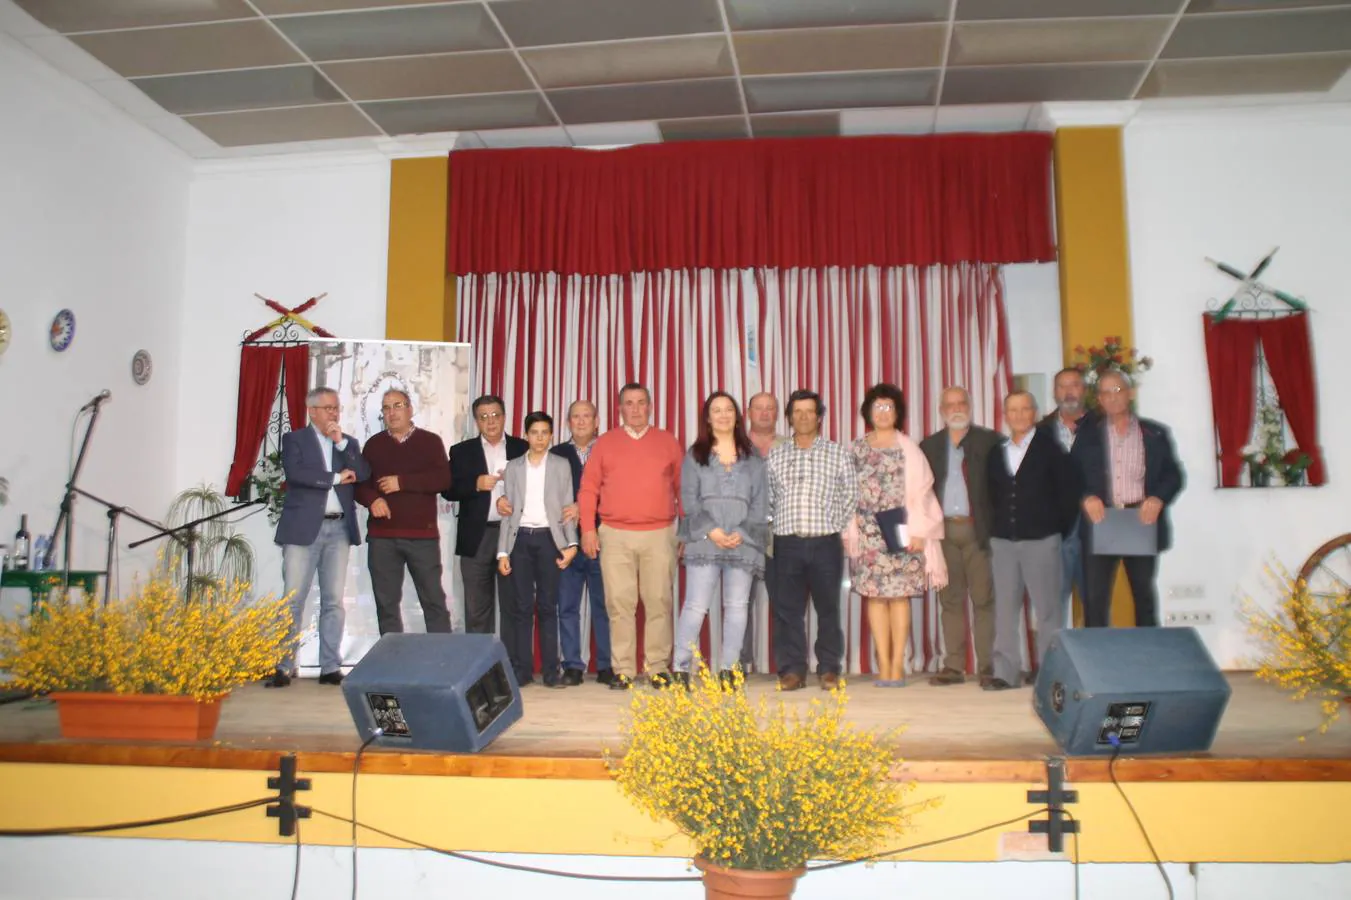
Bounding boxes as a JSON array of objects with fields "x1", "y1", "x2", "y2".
[{"x1": 385, "y1": 155, "x2": 455, "y2": 341}]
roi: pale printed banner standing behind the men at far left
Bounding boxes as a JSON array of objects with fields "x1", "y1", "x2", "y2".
[{"x1": 297, "y1": 341, "x2": 473, "y2": 666}]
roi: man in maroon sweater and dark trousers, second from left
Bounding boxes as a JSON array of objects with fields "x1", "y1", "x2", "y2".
[{"x1": 357, "y1": 389, "x2": 450, "y2": 635}]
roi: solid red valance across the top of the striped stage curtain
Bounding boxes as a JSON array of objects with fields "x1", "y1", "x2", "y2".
[{"x1": 447, "y1": 132, "x2": 1055, "y2": 274}]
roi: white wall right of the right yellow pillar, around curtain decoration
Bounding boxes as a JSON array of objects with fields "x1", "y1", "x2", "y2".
[{"x1": 1125, "y1": 105, "x2": 1351, "y2": 666}]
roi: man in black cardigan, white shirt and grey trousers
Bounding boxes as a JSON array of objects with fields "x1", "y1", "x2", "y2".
[{"x1": 984, "y1": 391, "x2": 1081, "y2": 691}]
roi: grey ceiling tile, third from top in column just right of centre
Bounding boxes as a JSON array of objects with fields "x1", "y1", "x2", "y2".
[{"x1": 743, "y1": 70, "x2": 938, "y2": 112}]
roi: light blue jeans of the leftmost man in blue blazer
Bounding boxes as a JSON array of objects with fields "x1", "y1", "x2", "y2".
[{"x1": 277, "y1": 519, "x2": 351, "y2": 674}]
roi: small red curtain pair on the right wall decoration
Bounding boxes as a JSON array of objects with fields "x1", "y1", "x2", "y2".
[{"x1": 1201, "y1": 312, "x2": 1327, "y2": 488}]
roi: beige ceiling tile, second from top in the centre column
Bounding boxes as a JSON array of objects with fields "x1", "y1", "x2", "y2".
[{"x1": 520, "y1": 35, "x2": 734, "y2": 88}]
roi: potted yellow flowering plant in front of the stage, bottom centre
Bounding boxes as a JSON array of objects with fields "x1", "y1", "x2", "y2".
[{"x1": 607, "y1": 664, "x2": 927, "y2": 900}]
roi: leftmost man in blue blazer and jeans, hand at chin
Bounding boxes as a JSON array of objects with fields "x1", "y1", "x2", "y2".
[{"x1": 267, "y1": 388, "x2": 370, "y2": 688}]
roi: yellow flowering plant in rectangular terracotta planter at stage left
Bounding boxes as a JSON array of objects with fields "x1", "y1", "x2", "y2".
[{"x1": 0, "y1": 576, "x2": 289, "y2": 741}]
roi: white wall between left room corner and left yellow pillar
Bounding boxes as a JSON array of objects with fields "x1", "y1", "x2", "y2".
[{"x1": 174, "y1": 155, "x2": 389, "y2": 592}]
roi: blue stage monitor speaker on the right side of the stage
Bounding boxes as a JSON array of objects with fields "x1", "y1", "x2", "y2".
[{"x1": 1032, "y1": 628, "x2": 1229, "y2": 755}]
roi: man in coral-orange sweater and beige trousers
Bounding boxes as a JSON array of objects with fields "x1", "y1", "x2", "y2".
[{"x1": 577, "y1": 384, "x2": 685, "y2": 691}]
